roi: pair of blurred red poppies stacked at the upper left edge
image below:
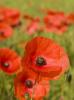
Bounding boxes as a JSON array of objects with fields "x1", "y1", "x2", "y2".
[{"x1": 0, "y1": 8, "x2": 20, "y2": 41}]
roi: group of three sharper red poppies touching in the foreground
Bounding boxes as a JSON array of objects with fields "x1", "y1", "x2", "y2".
[{"x1": 0, "y1": 36, "x2": 69, "y2": 100}]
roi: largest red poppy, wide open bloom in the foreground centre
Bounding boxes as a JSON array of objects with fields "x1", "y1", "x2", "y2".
[{"x1": 22, "y1": 37, "x2": 69, "y2": 79}]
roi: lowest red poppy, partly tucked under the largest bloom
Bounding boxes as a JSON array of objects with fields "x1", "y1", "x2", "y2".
[{"x1": 14, "y1": 73, "x2": 50, "y2": 100}]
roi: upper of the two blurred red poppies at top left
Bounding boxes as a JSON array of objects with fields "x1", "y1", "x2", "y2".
[{"x1": 1, "y1": 8, "x2": 20, "y2": 26}]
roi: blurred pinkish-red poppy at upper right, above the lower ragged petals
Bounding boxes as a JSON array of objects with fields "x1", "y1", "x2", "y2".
[{"x1": 44, "y1": 11, "x2": 67, "y2": 26}]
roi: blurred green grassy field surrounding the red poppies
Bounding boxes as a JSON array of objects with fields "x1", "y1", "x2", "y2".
[{"x1": 0, "y1": 0, "x2": 74, "y2": 100}]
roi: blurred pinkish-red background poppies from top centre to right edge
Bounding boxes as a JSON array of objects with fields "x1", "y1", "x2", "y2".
[{"x1": 24, "y1": 10, "x2": 74, "y2": 35}]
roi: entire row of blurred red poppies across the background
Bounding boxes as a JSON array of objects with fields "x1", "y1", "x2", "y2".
[{"x1": 0, "y1": 8, "x2": 74, "y2": 41}]
